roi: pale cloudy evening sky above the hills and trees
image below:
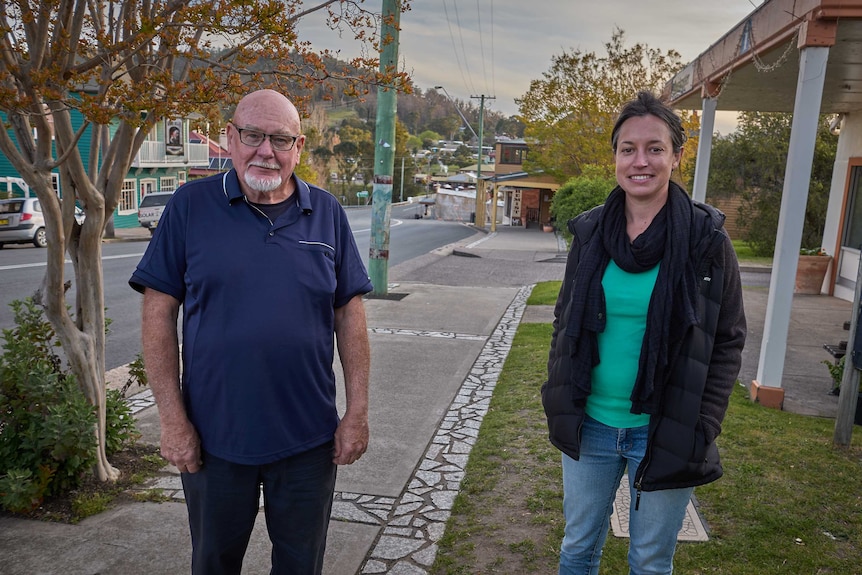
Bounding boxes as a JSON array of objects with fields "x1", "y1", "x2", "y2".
[{"x1": 298, "y1": 0, "x2": 762, "y2": 134}]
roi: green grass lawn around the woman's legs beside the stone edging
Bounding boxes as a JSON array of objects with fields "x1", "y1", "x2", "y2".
[{"x1": 432, "y1": 282, "x2": 862, "y2": 575}]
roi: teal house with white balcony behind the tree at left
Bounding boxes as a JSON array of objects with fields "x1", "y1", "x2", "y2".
[{"x1": 0, "y1": 112, "x2": 210, "y2": 228}]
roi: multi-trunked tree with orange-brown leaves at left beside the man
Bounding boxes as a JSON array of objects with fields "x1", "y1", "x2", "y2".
[{"x1": 0, "y1": 0, "x2": 409, "y2": 480}]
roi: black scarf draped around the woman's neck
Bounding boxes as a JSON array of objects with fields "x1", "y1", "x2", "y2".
[{"x1": 566, "y1": 182, "x2": 697, "y2": 413}]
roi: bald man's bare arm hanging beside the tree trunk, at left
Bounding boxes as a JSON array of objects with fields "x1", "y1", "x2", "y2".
[{"x1": 141, "y1": 288, "x2": 201, "y2": 473}]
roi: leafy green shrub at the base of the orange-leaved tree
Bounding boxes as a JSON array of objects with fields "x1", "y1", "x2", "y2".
[{"x1": 0, "y1": 298, "x2": 142, "y2": 513}]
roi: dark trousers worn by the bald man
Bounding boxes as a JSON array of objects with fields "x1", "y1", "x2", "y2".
[{"x1": 182, "y1": 442, "x2": 337, "y2": 575}]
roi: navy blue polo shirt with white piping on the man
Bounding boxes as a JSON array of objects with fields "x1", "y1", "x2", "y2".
[{"x1": 129, "y1": 170, "x2": 372, "y2": 465}]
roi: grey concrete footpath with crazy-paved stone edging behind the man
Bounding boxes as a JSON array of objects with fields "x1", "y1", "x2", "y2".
[{"x1": 0, "y1": 222, "x2": 850, "y2": 575}]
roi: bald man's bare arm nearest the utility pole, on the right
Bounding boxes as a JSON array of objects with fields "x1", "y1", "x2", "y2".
[{"x1": 332, "y1": 295, "x2": 371, "y2": 465}]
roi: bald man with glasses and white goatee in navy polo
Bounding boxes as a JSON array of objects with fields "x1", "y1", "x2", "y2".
[{"x1": 129, "y1": 90, "x2": 372, "y2": 575}]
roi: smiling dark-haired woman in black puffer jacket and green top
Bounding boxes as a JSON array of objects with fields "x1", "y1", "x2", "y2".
[{"x1": 542, "y1": 92, "x2": 745, "y2": 575}]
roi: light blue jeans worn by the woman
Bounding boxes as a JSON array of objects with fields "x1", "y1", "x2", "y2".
[{"x1": 559, "y1": 417, "x2": 693, "y2": 575}]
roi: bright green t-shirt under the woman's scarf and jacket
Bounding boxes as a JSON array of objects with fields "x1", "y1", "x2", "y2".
[{"x1": 586, "y1": 260, "x2": 661, "y2": 429}]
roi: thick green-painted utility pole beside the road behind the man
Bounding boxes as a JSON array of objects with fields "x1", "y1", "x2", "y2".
[{"x1": 368, "y1": 0, "x2": 401, "y2": 296}]
